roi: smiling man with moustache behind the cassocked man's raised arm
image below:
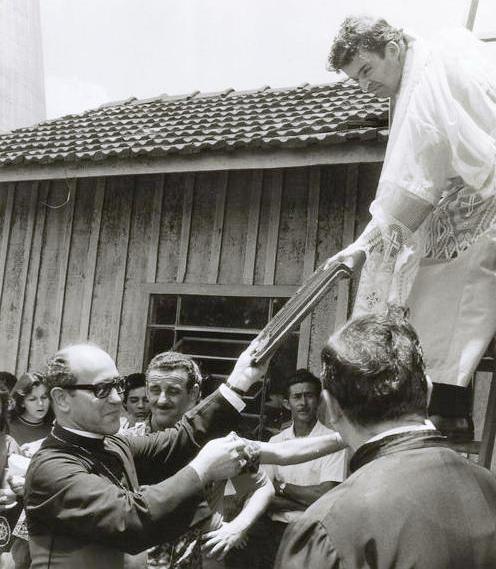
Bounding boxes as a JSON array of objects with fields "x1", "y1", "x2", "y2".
[{"x1": 121, "y1": 351, "x2": 274, "y2": 569}]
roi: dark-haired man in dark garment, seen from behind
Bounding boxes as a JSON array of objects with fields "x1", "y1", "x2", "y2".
[{"x1": 276, "y1": 308, "x2": 496, "y2": 569}]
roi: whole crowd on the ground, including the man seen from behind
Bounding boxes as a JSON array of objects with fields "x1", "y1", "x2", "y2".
[{"x1": 0, "y1": 306, "x2": 496, "y2": 569}]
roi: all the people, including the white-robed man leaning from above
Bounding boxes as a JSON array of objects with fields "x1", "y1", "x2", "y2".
[{"x1": 0, "y1": 10, "x2": 496, "y2": 569}]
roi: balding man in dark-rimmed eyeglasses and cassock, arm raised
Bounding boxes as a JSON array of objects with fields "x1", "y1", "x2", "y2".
[{"x1": 25, "y1": 344, "x2": 263, "y2": 569}]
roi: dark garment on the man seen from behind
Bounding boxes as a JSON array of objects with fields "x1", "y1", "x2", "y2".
[{"x1": 275, "y1": 431, "x2": 496, "y2": 569}]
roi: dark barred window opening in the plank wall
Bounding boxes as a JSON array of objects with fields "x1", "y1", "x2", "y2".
[{"x1": 145, "y1": 294, "x2": 299, "y2": 438}]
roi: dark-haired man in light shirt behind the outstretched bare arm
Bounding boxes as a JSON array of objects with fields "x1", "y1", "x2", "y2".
[{"x1": 240, "y1": 369, "x2": 347, "y2": 567}]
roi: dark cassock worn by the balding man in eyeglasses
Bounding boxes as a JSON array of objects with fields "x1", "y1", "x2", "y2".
[{"x1": 25, "y1": 392, "x2": 239, "y2": 569}]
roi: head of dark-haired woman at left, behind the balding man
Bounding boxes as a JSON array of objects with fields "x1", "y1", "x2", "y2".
[{"x1": 9, "y1": 372, "x2": 53, "y2": 446}]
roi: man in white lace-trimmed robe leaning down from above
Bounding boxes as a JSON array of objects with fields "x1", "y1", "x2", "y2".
[{"x1": 329, "y1": 16, "x2": 496, "y2": 422}]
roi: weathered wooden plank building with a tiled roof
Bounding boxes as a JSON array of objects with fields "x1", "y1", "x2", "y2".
[{"x1": 0, "y1": 83, "x2": 387, "y2": 390}]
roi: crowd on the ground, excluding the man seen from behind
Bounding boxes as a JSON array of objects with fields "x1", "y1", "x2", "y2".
[{"x1": 0, "y1": 344, "x2": 346, "y2": 569}]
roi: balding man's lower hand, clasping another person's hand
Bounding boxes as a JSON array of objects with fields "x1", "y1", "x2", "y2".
[{"x1": 190, "y1": 435, "x2": 247, "y2": 484}]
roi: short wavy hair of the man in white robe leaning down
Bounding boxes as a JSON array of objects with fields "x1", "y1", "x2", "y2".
[{"x1": 328, "y1": 16, "x2": 403, "y2": 71}]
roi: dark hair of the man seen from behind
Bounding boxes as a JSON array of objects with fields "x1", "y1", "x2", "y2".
[{"x1": 322, "y1": 306, "x2": 427, "y2": 426}]
